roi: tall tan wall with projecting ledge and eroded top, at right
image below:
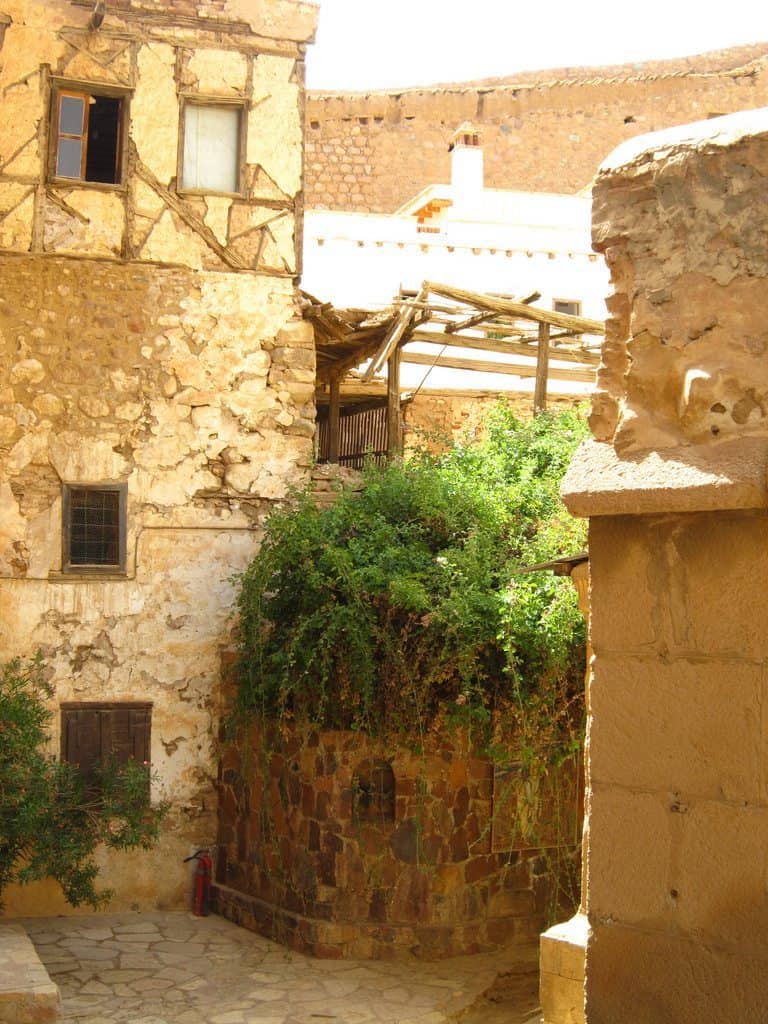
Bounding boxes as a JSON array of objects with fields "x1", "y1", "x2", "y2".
[{"x1": 563, "y1": 110, "x2": 768, "y2": 1024}]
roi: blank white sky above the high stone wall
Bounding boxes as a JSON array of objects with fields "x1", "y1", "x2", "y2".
[{"x1": 307, "y1": 0, "x2": 768, "y2": 90}]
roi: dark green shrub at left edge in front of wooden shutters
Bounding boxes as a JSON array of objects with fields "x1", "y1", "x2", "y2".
[{"x1": 0, "y1": 657, "x2": 166, "y2": 908}]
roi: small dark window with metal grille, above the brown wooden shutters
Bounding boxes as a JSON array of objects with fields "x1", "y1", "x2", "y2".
[{"x1": 62, "y1": 484, "x2": 126, "y2": 572}]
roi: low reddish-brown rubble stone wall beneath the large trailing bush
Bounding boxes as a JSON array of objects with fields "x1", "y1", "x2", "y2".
[{"x1": 215, "y1": 728, "x2": 577, "y2": 958}]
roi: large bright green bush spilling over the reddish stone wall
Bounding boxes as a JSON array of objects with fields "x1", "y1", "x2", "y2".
[{"x1": 239, "y1": 404, "x2": 585, "y2": 745}]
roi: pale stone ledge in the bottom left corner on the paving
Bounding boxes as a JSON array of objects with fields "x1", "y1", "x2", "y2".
[{"x1": 0, "y1": 925, "x2": 58, "y2": 1024}]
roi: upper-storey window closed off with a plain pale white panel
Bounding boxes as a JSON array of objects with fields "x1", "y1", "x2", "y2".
[{"x1": 180, "y1": 101, "x2": 243, "y2": 193}]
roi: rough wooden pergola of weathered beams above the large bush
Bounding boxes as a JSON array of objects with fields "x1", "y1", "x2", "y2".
[{"x1": 303, "y1": 281, "x2": 605, "y2": 462}]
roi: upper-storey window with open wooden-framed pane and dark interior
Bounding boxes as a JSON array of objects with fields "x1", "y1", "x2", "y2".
[{"x1": 50, "y1": 87, "x2": 127, "y2": 185}]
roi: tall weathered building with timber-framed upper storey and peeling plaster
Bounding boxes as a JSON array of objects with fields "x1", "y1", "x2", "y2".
[{"x1": 0, "y1": 0, "x2": 316, "y2": 913}]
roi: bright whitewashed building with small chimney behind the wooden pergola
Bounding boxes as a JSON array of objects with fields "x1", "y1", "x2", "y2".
[{"x1": 303, "y1": 125, "x2": 608, "y2": 393}]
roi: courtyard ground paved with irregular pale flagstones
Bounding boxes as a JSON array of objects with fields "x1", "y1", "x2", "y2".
[{"x1": 20, "y1": 913, "x2": 538, "y2": 1024}]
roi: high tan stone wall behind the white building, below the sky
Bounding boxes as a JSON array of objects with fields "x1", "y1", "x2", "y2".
[{"x1": 306, "y1": 44, "x2": 768, "y2": 213}]
